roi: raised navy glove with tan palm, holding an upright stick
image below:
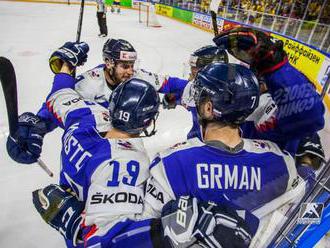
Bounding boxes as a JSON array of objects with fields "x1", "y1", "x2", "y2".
[{"x1": 49, "y1": 42, "x2": 89, "y2": 74}]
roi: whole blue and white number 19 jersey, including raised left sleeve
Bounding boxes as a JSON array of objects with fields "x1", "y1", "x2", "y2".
[{"x1": 47, "y1": 74, "x2": 150, "y2": 245}]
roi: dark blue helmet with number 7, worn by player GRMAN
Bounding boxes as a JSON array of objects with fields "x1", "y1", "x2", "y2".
[{"x1": 194, "y1": 63, "x2": 259, "y2": 125}]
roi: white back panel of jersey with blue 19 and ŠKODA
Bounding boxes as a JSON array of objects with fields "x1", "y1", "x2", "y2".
[{"x1": 85, "y1": 139, "x2": 150, "y2": 229}]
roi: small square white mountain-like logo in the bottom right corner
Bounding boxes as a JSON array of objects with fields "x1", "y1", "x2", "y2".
[{"x1": 298, "y1": 202, "x2": 324, "y2": 225}]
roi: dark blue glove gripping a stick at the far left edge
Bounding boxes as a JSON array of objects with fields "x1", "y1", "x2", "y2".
[{"x1": 7, "y1": 112, "x2": 47, "y2": 164}]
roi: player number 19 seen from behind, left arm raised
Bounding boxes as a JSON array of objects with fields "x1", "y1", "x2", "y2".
[{"x1": 33, "y1": 48, "x2": 258, "y2": 247}]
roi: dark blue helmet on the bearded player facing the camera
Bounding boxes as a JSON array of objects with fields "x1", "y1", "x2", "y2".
[{"x1": 102, "y1": 39, "x2": 137, "y2": 62}]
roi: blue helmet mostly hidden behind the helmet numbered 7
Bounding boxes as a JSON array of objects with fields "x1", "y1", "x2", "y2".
[{"x1": 189, "y1": 45, "x2": 228, "y2": 69}]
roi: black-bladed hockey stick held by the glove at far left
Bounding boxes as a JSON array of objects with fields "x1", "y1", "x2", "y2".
[{"x1": 0, "y1": 57, "x2": 54, "y2": 177}]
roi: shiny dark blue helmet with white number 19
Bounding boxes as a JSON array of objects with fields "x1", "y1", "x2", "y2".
[{"x1": 109, "y1": 78, "x2": 160, "y2": 136}]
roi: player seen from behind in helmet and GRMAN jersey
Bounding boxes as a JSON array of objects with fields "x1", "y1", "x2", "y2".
[{"x1": 145, "y1": 63, "x2": 308, "y2": 247}]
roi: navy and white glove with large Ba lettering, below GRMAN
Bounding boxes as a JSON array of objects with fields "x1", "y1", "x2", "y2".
[{"x1": 162, "y1": 196, "x2": 259, "y2": 248}]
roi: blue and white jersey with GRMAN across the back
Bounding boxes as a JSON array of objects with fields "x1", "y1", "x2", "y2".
[{"x1": 146, "y1": 138, "x2": 298, "y2": 215}]
